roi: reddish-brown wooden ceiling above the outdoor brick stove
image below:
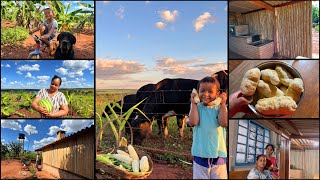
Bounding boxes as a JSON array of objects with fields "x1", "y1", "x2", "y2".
[{"x1": 229, "y1": 1, "x2": 290, "y2": 13}]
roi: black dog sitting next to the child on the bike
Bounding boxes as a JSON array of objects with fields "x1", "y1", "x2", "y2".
[{"x1": 54, "y1": 32, "x2": 76, "y2": 59}]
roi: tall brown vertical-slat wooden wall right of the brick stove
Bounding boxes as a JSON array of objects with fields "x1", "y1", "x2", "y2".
[{"x1": 275, "y1": 1, "x2": 312, "y2": 58}]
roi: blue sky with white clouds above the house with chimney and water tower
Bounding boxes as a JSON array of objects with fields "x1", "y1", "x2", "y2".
[{"x1": 1, "y1": 119, "x2": 93, "y2": 151}]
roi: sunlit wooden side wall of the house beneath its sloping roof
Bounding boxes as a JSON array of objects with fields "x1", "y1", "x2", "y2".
[{"x1": 42, "y1": 131, "x2": 95, "y2": 179}]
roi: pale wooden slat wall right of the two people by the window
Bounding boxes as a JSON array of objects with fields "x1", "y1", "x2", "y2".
[{"x1": 290, "y1": 150, "x2": 319, "y2": 179}]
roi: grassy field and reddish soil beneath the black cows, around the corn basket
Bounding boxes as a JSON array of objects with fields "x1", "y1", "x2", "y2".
[{"x1": 96, "y1": 90, "x2": 192, "y2": 179}]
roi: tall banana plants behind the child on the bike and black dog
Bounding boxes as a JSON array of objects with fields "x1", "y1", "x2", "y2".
[{"x1": 1, "y1": 0, "x2": 94, "y2": 33}]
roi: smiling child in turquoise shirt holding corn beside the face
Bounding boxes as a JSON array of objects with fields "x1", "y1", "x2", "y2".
[{"x1": 187, "y1": 77, "x2": 228, "y2": 179}]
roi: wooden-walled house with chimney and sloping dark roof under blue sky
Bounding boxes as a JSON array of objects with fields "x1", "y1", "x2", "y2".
[{"x1": 36, "y1": 125, "x2": 95, "y2": 179}]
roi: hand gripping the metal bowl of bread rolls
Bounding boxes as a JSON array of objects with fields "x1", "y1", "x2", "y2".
[{"x1": 229, "y1": 90, "x2": 253, "y2": 117}]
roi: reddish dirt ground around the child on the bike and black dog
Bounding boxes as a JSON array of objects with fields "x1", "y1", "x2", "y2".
[{"x1": 1, "y1": 23, "x2": 94, "y2": 59}]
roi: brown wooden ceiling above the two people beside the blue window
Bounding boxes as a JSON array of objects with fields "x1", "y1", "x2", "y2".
[{"x1": 272, "y1": 119, "x2": 319, "y2": 150}]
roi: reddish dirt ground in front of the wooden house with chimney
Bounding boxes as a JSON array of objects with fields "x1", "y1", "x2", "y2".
[{"x1": 1, "y1": 159, "x2": 56, "y2": 179}]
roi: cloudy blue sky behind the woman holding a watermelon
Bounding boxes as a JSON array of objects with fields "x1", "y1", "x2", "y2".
[{"x1": 1, "y1": 60, "x2": 94, "y2": 89}]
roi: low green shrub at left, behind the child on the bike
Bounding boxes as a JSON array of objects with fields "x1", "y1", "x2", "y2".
[{"x1": 1, "y1": 26, "x2": 29, "y2": 45}]
